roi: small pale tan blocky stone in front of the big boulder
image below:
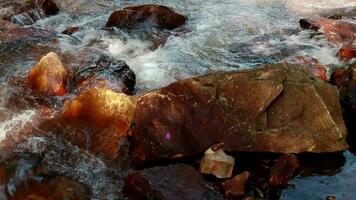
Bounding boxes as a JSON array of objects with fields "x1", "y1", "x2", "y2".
[{"x1": 200, "y1": 145, "x2": 235, "y2": 178}]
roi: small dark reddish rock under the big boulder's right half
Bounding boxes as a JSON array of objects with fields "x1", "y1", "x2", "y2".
[{"x1": 268, "y1": 154, "x2": 300, "y2": 188}]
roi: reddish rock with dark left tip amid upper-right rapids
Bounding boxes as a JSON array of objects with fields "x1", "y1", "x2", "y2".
[{"x1": 299, "y1": 17, "x2": 356, "y2": 44}]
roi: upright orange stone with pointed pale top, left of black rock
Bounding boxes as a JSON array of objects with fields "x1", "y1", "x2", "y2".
[{"x1": 28, "y1": 52, "x2": 68, "y2": 96}]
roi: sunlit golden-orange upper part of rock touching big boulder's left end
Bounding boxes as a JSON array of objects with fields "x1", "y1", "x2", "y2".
[{"x1": 61, "y1": 88, "x2": 136, "y2": 133}]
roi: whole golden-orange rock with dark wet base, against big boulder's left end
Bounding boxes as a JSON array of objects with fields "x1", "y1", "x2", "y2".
[{"x1": 59, "y1": 89, "x2": 136, "y2": 160}]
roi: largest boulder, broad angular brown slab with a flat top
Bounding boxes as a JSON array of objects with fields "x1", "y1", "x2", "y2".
[{"x1": 131, "y1": 63, "x2": 348, "y2": 163}]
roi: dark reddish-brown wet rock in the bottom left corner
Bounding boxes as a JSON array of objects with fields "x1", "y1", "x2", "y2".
[{"x1": 8, "y1": 177, "x2": 90, "y2": 200}]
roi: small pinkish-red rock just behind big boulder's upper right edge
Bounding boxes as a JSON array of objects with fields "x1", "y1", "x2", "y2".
[{"x1": 287, "y1": 56, "x2": 328, "y2": 81}]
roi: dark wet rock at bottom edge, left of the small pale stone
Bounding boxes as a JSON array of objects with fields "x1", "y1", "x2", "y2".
[{"x1": 123, "y1": 164, "x2": 222, "y2": 200}]
